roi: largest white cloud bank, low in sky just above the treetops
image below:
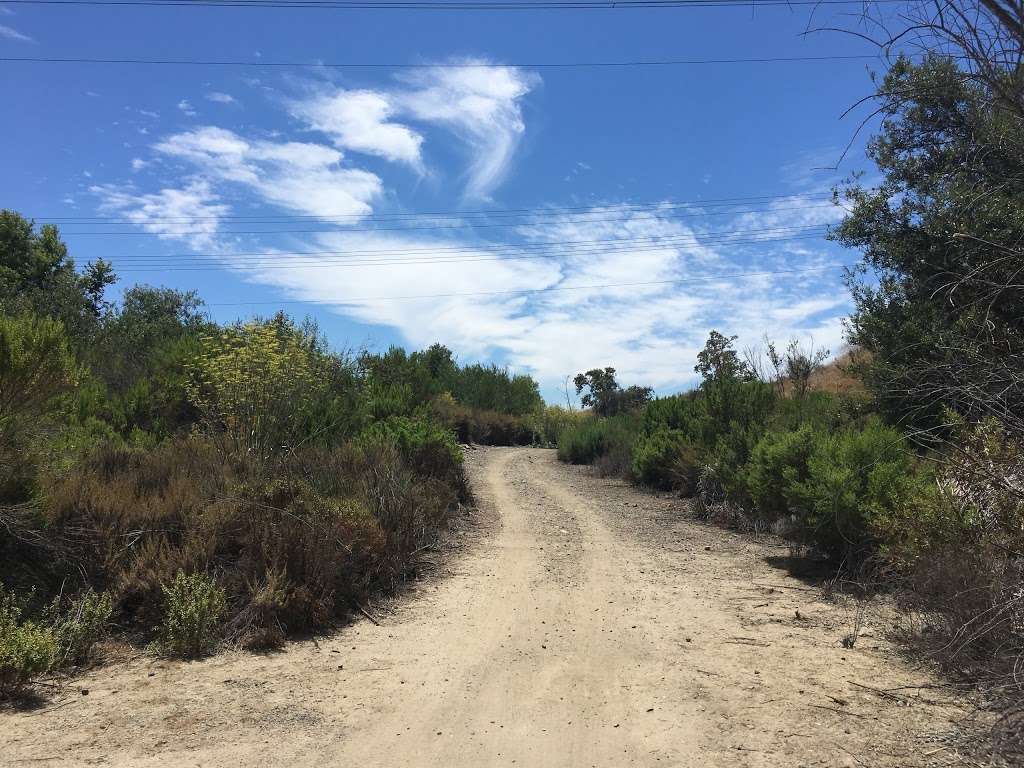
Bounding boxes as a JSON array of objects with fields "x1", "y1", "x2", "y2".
[{"x1": 222, "y1": 206, "x2": 849, "y2": 391}]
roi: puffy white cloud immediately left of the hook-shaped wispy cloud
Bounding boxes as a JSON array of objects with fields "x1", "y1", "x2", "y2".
[{"x1": 292, "y1": 89, "x2": 423, "y2": 170}]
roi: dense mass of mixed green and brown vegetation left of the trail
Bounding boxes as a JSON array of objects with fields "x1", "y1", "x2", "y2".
[{"x1": 0, "y1": 211, "x2": 570, "y2": 694}]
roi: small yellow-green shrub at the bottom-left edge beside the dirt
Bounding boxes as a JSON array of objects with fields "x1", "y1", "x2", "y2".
[{"x1": 0, "y1": 587, "x2": 57, "y2": 696}]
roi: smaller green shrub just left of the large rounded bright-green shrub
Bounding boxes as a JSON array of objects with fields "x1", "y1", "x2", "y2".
[{"x1": 745, "y1": 426, "x2": 815, "y2": 522}]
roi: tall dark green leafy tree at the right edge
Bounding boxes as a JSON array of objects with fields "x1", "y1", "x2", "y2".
[{"x1": 831, "y1": 56, "x2": 1024, "y2": 435}]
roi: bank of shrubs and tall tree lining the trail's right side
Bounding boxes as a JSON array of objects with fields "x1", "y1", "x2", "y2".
[{"x1": 558, "y1": 46, "x2": 1024, "y2": 755}]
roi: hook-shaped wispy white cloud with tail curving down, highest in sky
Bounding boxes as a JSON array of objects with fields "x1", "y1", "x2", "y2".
[{"x1": 398, "y1": 59, "x2": 541, "y2": 199}]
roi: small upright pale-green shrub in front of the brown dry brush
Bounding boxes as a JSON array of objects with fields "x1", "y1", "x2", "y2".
[{"x1": 159, "y1": 570, "x2": 225, "y2": 658}]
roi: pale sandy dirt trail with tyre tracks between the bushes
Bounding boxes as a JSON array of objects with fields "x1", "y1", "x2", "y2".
[{"x1": 0, "y1": 449, "x2": 965, "y2": 768}]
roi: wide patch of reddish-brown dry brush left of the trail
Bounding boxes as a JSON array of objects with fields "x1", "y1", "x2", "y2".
[{"x1": 5, "y1": 439, "x2": 466, "y2": 646}]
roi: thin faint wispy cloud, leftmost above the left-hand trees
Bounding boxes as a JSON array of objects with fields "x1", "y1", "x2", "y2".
[{"x1": 89, "y1": 181, "x2": 228, "y2": 248}]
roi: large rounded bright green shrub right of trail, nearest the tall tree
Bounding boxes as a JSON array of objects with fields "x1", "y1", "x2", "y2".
[{"x1": 785, "y1": 417, "x2": 921, "y2": 562}]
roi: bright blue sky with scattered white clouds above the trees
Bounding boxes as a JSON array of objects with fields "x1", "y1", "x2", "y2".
[{"x1": 0, "y1": 4, "x2": 888, "y2": 400}]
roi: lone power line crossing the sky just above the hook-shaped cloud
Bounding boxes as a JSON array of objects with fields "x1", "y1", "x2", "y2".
[{"x1": 0, "y1": 53, "x2": 881, "y2": 70}]
